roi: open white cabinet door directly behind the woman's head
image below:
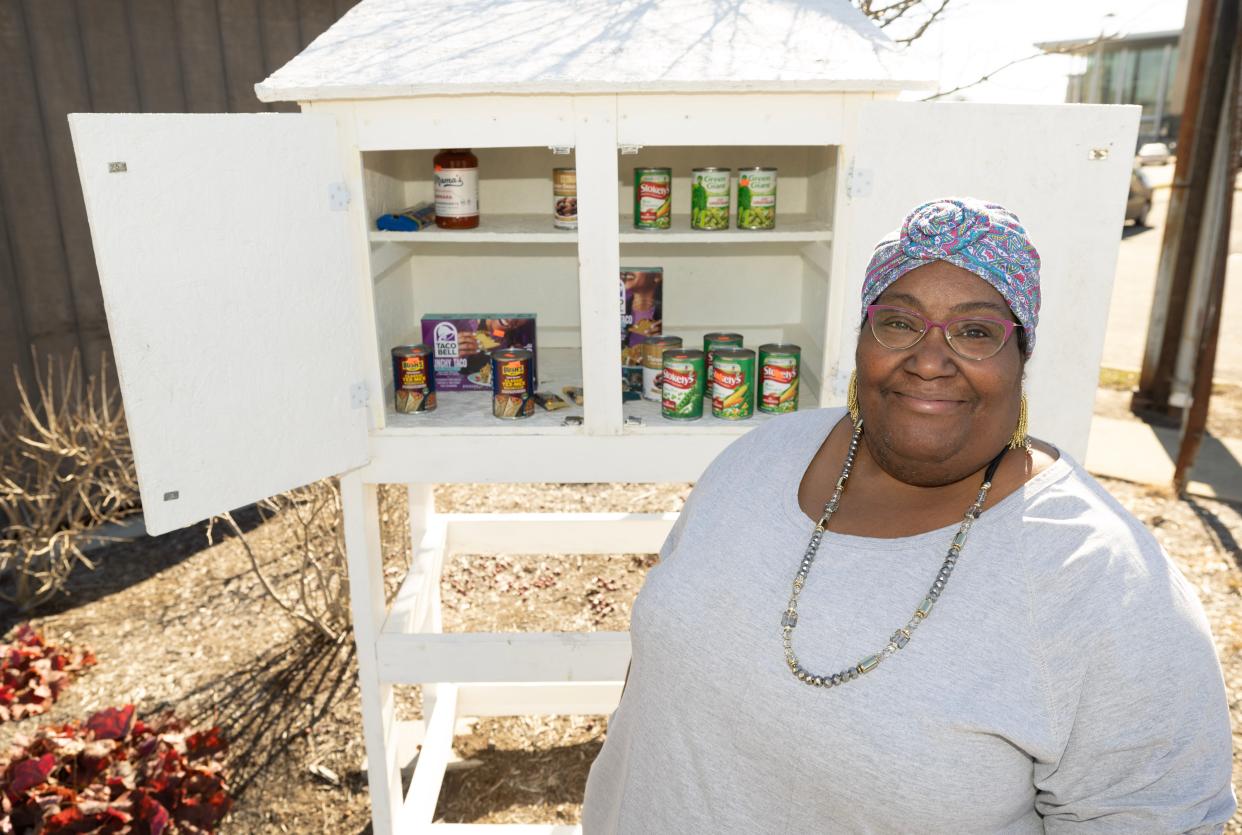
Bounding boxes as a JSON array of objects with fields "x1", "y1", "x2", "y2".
[{"x1": 835, "y1": 102, "x2": 1143, "y2": 461}]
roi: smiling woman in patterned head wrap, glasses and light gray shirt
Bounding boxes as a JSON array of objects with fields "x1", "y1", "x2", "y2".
[{"x1": 582, "y1": 199, "x2": 1236, "y2": 834}]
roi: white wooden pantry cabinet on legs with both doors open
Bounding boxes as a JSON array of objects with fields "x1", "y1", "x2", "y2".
[{"x1": 70, "y1": 0, "x2": 1139, "y2": 833}]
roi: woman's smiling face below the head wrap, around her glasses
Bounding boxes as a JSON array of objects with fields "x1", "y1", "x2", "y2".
[{"x1": 856, "y1": 261, "x2": 1022, "y2": 487}]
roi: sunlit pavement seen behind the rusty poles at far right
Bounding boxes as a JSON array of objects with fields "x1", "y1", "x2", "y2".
[{"x1": 1103, "y1": 164, "x2": 1242, "y2": 383}]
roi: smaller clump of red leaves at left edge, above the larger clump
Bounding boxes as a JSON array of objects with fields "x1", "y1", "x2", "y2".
[{"x1": 0, "y1": 624, "x2": 94, "y2": 722}]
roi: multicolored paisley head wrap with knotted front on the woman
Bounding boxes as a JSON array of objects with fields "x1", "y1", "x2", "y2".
[{"x1": 862, "y1": 198, "x2": 1040, "y2": 357}]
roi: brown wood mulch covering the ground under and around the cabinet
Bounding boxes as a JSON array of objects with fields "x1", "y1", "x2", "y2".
[{"x1": 0, "y1": 406, "x2": 1242, "y2": 835}]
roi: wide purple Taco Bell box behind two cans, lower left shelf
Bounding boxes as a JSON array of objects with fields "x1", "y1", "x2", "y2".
[{"x1": 422, "y1": 313, "x2": 539, "y2": 391}]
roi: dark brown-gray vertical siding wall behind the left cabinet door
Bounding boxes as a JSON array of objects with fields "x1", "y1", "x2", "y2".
[{"x1": 0, "y1": 0, "x2": 356, "y2": 418}]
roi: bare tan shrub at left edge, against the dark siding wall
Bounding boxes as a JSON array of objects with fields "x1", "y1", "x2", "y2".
[{"x1": 0, "y1": 352, "x2": 138, "y2": 611}]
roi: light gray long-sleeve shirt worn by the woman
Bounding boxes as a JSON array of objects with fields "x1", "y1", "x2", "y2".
[{"x1": 582, "y1": 409, "x2": 1235, "y2": 835}]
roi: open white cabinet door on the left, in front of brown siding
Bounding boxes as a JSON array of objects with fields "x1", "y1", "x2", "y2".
[{"x1": 70, "y1": 113, "x2": 368, "y2": 534}]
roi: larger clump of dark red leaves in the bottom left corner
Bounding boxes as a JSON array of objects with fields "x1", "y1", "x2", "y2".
[{"x1": 0, "y1": 705, "x2": 232, "y2": 835}]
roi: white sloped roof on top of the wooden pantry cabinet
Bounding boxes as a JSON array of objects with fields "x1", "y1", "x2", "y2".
[{"x1": 255, "y1": 0, "x2": 933, "y2": 102}]
